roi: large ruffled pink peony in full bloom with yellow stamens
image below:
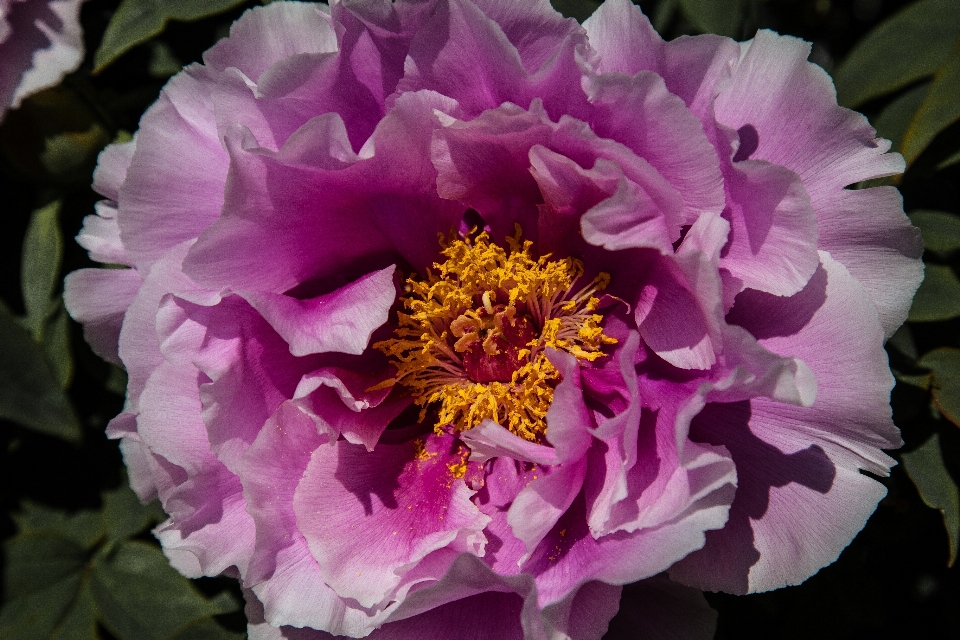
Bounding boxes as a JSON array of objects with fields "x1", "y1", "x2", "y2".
[{"x1": 66, "y1": 0, "x2": 921, "y2": 640}]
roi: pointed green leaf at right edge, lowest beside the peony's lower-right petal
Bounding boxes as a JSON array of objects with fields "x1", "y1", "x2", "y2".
[{"x1": 902, "y1": 433, "x2": 960, "y2": 567}]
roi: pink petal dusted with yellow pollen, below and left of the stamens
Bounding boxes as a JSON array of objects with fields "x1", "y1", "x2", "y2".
[{"x1": 293, "y1": 435, "x2": 489, "y2": 607}]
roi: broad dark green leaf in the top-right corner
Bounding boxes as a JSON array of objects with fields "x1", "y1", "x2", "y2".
[{"x1": 833, "y1": 0, "x2": 960, "y2": 107}]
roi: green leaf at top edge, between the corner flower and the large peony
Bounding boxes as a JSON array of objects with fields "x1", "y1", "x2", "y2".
[{"x1": 93, "y1": 0, "x2": 246, "y2": 73}]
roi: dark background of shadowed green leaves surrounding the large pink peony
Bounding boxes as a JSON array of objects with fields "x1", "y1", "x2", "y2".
[{"x1": 0, "y1": 0, "x2": 960, "y2": 640}]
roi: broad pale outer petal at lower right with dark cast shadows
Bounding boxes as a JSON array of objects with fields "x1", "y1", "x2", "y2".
[{"x1": 671, "y1": 253, "x2": 900, "y2": 593}]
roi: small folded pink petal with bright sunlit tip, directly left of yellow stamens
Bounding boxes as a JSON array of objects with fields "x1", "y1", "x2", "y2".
[{"x1": 243, "y1": 266, "x2": 396, "y2": 356}]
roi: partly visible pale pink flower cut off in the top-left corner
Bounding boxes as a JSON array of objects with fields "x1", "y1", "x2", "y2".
[{"x1": 0, "y1": 0, "x2": 83, "y2": 120}]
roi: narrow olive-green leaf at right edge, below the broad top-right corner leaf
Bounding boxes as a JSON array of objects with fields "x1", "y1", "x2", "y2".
[{"x1": 900, "y1": 46, "x2": 960, "y2": 166}]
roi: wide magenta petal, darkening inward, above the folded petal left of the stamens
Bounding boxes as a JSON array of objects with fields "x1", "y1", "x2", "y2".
[{"x1": 184, "y1": 123, "x2": 389, "y2": 293}]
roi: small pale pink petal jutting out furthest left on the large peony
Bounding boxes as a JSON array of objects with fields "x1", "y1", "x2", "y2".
[{"x1": 63, "y1": 269, "x2": 143, "y2": 364}]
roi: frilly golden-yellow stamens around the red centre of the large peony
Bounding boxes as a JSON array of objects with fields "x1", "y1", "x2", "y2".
[{"x1": 374, "y1": 225, "x2": 616, "y2": 442}]
